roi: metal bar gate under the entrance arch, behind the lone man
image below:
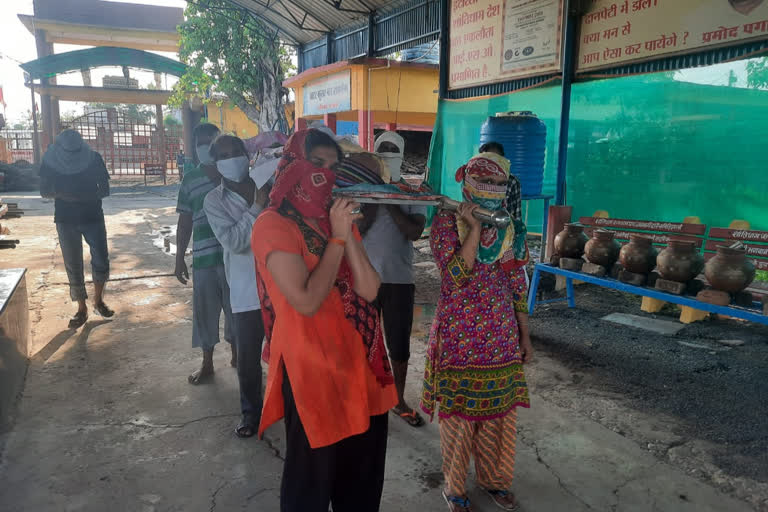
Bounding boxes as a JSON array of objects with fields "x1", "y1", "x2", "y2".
[{"x1": 62, "y1": 109, "x2": 183, "y2": 175}]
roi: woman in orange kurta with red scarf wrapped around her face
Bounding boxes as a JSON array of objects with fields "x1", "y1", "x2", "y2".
[{"x1": 252, "y1": 130, "x2": 397, "y2": 512}]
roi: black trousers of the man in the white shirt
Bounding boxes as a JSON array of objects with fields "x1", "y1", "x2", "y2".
[{"x1": 232, "y1": 309, "x2": 264, "y2": 428}]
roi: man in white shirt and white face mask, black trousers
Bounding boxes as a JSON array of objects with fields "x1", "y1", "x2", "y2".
[{"x1": 204, "y1": 135, "x2": 270, "y2": 438}]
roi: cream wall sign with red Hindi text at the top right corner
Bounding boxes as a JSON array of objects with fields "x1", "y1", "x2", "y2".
[{"x1": 576, "y1": 0, "x2": 768, "y2": 71}]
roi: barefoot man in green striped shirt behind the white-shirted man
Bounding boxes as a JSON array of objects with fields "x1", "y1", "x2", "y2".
[{"x1": 174, "y1": 123, "x2": 237, "y2": 384}]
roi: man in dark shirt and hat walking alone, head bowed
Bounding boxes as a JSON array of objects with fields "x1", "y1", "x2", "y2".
[{"x1": 40, "y1": 130, "x2": 115, "y2": 329}]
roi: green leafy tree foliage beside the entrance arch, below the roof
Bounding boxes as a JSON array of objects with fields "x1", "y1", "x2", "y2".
[{"x1": 171, "y1": 0, "x2": 292, "y2": 131}]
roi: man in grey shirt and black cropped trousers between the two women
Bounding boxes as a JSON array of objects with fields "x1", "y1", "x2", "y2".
[{"x1": 360, "y1": 132, "x2": 427, "y2": 427}]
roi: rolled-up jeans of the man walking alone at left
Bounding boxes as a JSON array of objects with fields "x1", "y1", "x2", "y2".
[{"x1": 56, "y1": 220, "x2": 109, "y2": 301}]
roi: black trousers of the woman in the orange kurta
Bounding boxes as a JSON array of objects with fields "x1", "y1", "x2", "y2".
[{"x1": 280, "y1": 374, "x2": 389, "y2": 512}]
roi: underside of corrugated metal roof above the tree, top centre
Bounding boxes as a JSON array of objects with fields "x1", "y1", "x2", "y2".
[{"x1": 222, "y1": 0, "x2": 414, "y2": 44}]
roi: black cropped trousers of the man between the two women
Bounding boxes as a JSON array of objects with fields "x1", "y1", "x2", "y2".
[{"x1": 376, "y1": 283, "x2": 416, "y2": 363}]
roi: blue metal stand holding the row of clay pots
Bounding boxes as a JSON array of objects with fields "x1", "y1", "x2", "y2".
[{"x1": 528, "y1": 263, "x2": 768, "y2": 325}]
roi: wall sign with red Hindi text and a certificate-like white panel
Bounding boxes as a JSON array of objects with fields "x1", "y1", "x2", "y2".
[{"x1": 448, "y1": 0, "x2": 563, "y2": 89}]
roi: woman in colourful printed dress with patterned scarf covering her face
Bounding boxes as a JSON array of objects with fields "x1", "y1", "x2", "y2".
[{"x1": 421, "y1": 153, "x2": 533, "y2": 512}]
